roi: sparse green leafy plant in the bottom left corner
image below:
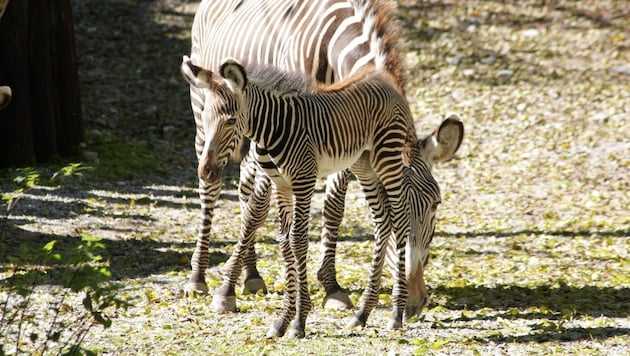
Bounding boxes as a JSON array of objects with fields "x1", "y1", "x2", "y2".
[{"x1": 0, "y1": 235, "x2": 129, "y2": 355}]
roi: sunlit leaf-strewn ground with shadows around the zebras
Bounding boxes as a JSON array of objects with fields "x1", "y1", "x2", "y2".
[{"x1": 0, "y1": 0, "x2": 630, "y2": 355}]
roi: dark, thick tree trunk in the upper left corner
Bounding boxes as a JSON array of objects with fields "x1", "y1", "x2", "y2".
[{"x1": 0, "y1": 0, "x2": 84, "y2": 167}]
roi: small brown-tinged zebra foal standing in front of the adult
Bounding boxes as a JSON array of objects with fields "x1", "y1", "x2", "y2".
[{"x1": 181, "y1": 56, "x2": 461, "y2": 337}]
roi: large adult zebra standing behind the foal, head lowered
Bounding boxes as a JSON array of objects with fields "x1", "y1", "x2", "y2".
[{"x1": 186, "y1": 0, "x2": 462, "y2": 323}]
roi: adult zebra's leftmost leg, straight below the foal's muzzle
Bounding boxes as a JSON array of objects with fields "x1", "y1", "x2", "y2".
[{"x1": 184, "y1": 179, "x2": 221, "y2": 294}]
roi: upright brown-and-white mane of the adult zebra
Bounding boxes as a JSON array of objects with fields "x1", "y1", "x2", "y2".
[{"x1": 350, "y1": 0, "x2": 406, "y2": 90}]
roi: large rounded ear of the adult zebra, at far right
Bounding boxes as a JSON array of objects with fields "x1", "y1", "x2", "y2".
[{"x1": 418, "y1": 114, "x2": 464, "y2": 164}]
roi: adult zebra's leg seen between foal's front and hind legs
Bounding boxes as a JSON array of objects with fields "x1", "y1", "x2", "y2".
[{"x1": 317, "y1": 170, "x2": 353, "y2": 309}]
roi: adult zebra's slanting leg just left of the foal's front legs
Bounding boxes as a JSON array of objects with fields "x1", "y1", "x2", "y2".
[{"x1": 212, "y1": 170, "x2": 271, "y2": 313}]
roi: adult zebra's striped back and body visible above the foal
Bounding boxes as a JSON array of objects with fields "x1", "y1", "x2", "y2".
[{"x1": 191, "y1": 0, "x2": 405, "y2": 89}]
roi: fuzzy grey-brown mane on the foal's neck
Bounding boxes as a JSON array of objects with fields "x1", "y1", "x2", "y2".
[{"x1": 246, "y1": 65, "x2": 317, "y2": 94}]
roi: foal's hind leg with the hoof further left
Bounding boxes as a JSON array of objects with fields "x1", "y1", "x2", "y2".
[{"x1": 348, "y1": 155, "x2": 392, "y2": 328}]
